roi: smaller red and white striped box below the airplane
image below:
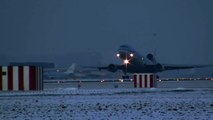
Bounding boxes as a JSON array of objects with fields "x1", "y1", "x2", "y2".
[{"x1": 133, "y1": 73, "x2": 156, "y2": 88}]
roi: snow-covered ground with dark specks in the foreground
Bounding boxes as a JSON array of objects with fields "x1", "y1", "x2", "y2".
[{"x1": 0, "y1": 88, "x2": 213, "y2": 120}]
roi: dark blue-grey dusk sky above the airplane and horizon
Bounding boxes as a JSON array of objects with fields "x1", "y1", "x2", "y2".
[{"x1": 0, "y1": 0, "x2": 213, "y2": 64}]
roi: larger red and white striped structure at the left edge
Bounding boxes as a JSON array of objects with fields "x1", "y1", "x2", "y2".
[{"x1": 0, "y1": 66, "x2": 43, "y2": 91}]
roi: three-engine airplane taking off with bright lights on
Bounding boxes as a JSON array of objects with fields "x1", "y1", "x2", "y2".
[{"x1": 97, "y1": 45, "x2": 209, "y2": 79}]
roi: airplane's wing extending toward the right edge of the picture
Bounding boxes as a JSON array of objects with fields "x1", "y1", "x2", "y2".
[{"x1": 163, "y1": 64, "x2": 212, "y2": 70}]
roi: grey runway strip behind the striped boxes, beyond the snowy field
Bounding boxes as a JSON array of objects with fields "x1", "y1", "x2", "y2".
[{"x1": 44, "y1": 80, "x2": 213, "y2": 90}]
